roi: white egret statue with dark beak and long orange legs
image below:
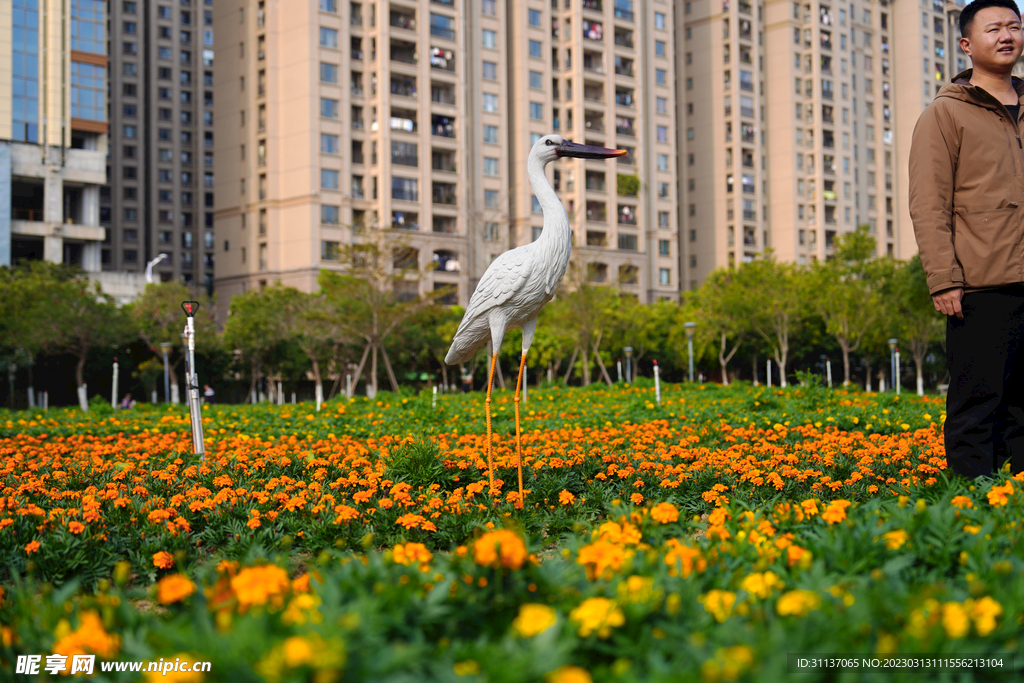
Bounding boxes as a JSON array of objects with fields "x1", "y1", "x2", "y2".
[{"x1": 444, "y1": 135, "x2": 627, "y2": 507}]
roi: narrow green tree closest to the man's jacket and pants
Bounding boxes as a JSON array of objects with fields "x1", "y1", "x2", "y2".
[{"x1": 892, "y1": 254, "x2": 945, "y2": 396}]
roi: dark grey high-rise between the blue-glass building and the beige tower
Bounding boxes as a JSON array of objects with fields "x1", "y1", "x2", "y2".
[{"x1": 100, "y1": 0, "x2": 216, "y2": 288}]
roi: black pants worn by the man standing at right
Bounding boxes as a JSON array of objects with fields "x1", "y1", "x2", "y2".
[{"x1": 945, "y1": 285, "x2": 1024, "y2": 478}]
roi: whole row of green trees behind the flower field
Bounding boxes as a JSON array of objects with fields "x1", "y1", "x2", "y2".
[{"x1": 0, "y1": 229, "x2": 944, "y2": 408}]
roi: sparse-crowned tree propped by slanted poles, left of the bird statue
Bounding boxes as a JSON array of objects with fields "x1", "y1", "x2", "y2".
[{"x1": 318, "y1": 227, "x2": 446, "y2": 397}]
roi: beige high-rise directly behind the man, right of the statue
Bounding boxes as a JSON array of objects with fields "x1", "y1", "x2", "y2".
[{"x1": 677, "y1": 0, "x2": 963, "y2": 287}]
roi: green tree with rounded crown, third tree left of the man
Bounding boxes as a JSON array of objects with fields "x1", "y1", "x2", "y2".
[{"x1": 736, "y1": 249, "x2": 807, "y2": 387}]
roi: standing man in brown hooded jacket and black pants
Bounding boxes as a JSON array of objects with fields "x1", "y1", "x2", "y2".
[{"x1": 909, "y1": 0, "x2": 1024, "y2": 478}]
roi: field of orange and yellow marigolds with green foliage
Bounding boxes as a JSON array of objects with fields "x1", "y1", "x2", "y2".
[{"x1": 0, "y1": 383, "x2": 1024, "y2": 683}]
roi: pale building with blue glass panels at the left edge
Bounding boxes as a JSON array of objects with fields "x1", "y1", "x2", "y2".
[{"x1": 0, "y1": 0, "x2": 108, "y2": 271}]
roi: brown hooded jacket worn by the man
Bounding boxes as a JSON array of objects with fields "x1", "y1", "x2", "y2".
[{"x1": 909, "y1": 70, "x2": 1024, "y2": 294}]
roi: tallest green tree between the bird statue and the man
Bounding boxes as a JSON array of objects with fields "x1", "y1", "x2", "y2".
[{"x1": 806, "y1": 225, "x2": 882, "y2": 385}]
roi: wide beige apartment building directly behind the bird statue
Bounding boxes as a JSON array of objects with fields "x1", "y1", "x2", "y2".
[{"x1": 213, "y1": 0, "x2": 679, "y2": 315}]
